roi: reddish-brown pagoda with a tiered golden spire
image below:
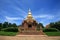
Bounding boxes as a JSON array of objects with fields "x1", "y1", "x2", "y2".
[{"x1": 18, "y1": 9, "x2": 43, "y2": 34}]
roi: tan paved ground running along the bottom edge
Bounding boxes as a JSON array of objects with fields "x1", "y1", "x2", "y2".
[{"x1": 0, "y1": 35, "x2": 60, "y2": 40}]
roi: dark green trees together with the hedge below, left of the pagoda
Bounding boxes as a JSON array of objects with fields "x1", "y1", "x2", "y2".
[{"x1": 0, "y1": 22, "x2": 18, "y2": 32}]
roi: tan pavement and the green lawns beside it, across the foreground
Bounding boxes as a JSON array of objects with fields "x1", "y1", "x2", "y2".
[{"x1": 0, "y1": 31, "x2": 60, "y2": 40}]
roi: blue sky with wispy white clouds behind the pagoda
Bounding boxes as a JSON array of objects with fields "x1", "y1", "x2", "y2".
[{"x1": 0, "y1": 0, "x2": 60, "y2": 26}]
